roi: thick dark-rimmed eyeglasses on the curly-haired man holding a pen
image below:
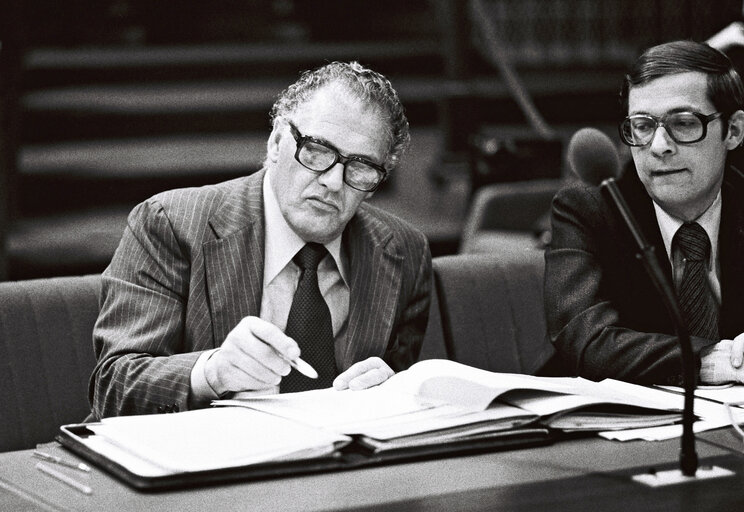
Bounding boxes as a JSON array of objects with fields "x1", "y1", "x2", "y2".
[{"x1": 288, "y1": 122, "x2": 387, "y2": 192}]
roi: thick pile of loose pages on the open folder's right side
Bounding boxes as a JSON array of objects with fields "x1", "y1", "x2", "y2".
[{"x1": 214, "y1": 360, "x2": 681, "y2": 451}]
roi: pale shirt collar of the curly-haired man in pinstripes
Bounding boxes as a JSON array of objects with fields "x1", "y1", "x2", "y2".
[{"x1": 263, "y1": 172, "x2": 349, "y2": 286}]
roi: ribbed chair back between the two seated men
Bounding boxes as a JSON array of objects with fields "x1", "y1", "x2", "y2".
[{"x1": 433, "y1": 250, "x2": 555, "y2": 374}]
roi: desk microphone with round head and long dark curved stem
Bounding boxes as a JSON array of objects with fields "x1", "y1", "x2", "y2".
[{"x1": 567, "y1": 128, "x2": 698, "y2": 476}]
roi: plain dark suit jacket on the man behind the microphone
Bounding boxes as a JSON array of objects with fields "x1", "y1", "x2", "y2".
[{"x1": 545, "y1": 166, "x2": 744, "y2": 383}]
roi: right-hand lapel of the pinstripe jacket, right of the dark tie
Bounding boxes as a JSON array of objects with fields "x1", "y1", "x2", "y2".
[{"x1": 339, "y1": 205, "x2": 403, "y2": 371}]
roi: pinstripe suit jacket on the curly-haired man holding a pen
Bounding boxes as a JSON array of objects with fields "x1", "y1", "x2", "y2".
[{"x1": 90, "y1": 171, "x2": 431, "y2": 417}]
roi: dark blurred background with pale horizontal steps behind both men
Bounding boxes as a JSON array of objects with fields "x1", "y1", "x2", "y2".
[{"x1": 0, "y1": 0, "x2": 742, "y2": 280}]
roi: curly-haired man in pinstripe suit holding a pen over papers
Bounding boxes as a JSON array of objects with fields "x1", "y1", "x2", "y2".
[{"x1": 90, "y1": 63, "x2": 431, "y2": 417}]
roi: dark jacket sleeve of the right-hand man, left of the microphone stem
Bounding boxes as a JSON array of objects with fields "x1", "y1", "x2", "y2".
[{"x1": 545, "y1": 182, "x2": 712, "y2": 384}]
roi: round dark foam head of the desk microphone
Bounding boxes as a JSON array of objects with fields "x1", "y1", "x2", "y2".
[{"x1": 567, "y1": 128, "x2": 622, "y2": 185}]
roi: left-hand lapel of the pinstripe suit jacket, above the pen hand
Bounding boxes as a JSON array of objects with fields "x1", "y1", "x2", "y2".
[{"x1": 203, "y1": 171, "x2": 264, "y2": 345}]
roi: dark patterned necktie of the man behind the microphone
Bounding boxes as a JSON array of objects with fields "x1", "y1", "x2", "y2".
[{"x1": 674, "y1": 222, "x2": 719, "y2": 340}]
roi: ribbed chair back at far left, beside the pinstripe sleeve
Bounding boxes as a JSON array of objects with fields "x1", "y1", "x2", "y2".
[{"x1": 0, "y1": 274, "x2": 101, "y2": 451}]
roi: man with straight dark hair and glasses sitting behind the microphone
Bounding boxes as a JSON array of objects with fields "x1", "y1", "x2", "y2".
[{"x1": 545, "y1": 41, "x2": 744, "y2": 384}]
